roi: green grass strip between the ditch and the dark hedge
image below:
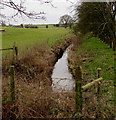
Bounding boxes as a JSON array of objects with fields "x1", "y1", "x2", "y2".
[{"x1": 76, "y1": 37, "x2": 115, "y2": 104}]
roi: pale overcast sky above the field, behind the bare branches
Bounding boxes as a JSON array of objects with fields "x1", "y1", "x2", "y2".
[{"x1": 3, "y1": 0, "x2": 79, "y2": 24}]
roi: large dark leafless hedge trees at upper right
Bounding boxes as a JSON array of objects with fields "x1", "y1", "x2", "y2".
[{"x1": 73, "y1": 2, "x2": 115, "y2": 50}]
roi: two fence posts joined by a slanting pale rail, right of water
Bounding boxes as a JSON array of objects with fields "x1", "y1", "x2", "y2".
[{"x1": 75, "y1": 66, "x2": 103, "y2": 113}]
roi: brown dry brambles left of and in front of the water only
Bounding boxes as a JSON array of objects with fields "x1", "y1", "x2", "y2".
[{"x1": 2, "y1": 39, "x2": 75, "y2": 119}]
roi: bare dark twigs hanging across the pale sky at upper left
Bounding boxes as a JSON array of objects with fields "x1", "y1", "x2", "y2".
[{"x1": 0, "y1": 0, "x2": 55, "y2": 21}]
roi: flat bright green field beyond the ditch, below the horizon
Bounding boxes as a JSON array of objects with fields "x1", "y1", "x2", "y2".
[{"x1": 2, "y1": 27, "x2": 71, "y2": 53}]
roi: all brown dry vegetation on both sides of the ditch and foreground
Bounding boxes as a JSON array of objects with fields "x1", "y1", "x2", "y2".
[{"x1": 3, "y1": 35, "x2": 113, "y2": 119}]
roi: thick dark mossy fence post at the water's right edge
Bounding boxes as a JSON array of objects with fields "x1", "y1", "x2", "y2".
[{"x1": 75, "y1": 66, "x2": 83, "y2": 113}]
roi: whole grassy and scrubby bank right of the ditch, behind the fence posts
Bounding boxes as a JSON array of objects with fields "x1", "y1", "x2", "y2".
[{"x1": 69, "y1": 37, "x2": 114, "y2": 118}]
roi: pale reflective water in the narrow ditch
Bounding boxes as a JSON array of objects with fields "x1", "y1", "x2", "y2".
[{"x1": 52, "y1": 46, "x2": 75, "y2": 92}]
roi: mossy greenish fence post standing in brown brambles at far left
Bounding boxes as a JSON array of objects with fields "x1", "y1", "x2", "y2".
[{"x1": 10, "y1": 66, "x2": 15, "y2": 101}]
